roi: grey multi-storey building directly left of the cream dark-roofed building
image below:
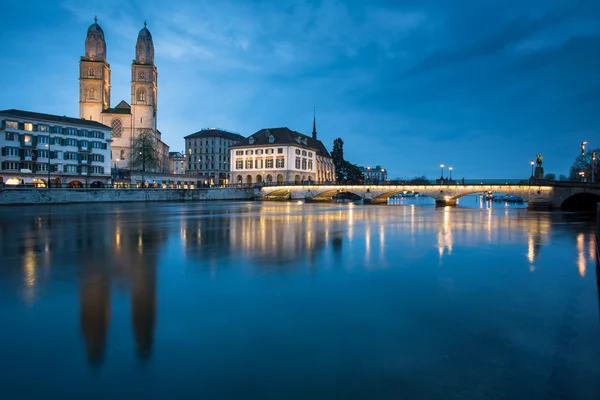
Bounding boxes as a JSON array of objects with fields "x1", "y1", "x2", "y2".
[{"x1": 184, "y1": 128, "x2": 245, "y2": 185}]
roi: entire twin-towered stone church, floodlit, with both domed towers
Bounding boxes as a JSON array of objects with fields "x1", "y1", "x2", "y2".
[{"x1": 79, "y1": 18, "x2": 169, "y2": 173}]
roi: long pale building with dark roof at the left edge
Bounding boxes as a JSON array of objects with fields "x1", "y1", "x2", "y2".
[{"x1": 0, "y1": 110, "x2": 111, "y2": 187}]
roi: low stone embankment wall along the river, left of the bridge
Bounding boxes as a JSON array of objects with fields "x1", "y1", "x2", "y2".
[{"x1": 0, "y1": 188, "x2": 255, "y2": 206}]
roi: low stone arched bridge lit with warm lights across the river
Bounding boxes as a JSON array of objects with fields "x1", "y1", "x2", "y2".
[{"x1": 259, "y1": 180, "x2": 600, "y2": 210}]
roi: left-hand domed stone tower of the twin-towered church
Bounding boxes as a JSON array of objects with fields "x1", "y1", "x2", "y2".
[{"x1": 79, "y1": 18, "x2": 110, "y2": 121}]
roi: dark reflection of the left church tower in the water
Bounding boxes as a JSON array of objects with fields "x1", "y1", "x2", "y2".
[{"x1": 80, "y1": 272, "x2": 110, "y2": 366}]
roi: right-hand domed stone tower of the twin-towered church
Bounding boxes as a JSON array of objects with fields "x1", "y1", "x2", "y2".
[{"x1": 131, "y1": 22, "x2": 158, "y2": 134}]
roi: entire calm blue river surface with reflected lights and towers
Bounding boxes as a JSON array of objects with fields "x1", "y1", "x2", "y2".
[{"x1": 0, "y1": 197, "x2": 600, "y2": 399}]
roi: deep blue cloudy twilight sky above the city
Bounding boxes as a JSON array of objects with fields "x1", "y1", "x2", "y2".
[{"x1": 0, "y1": 0, "x2": 600, "y2": 179}]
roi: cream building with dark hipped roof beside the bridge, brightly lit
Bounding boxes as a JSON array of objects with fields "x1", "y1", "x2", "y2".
[{"x1": 230, "y1": 126, "x2": 335, "y2": 185}]
